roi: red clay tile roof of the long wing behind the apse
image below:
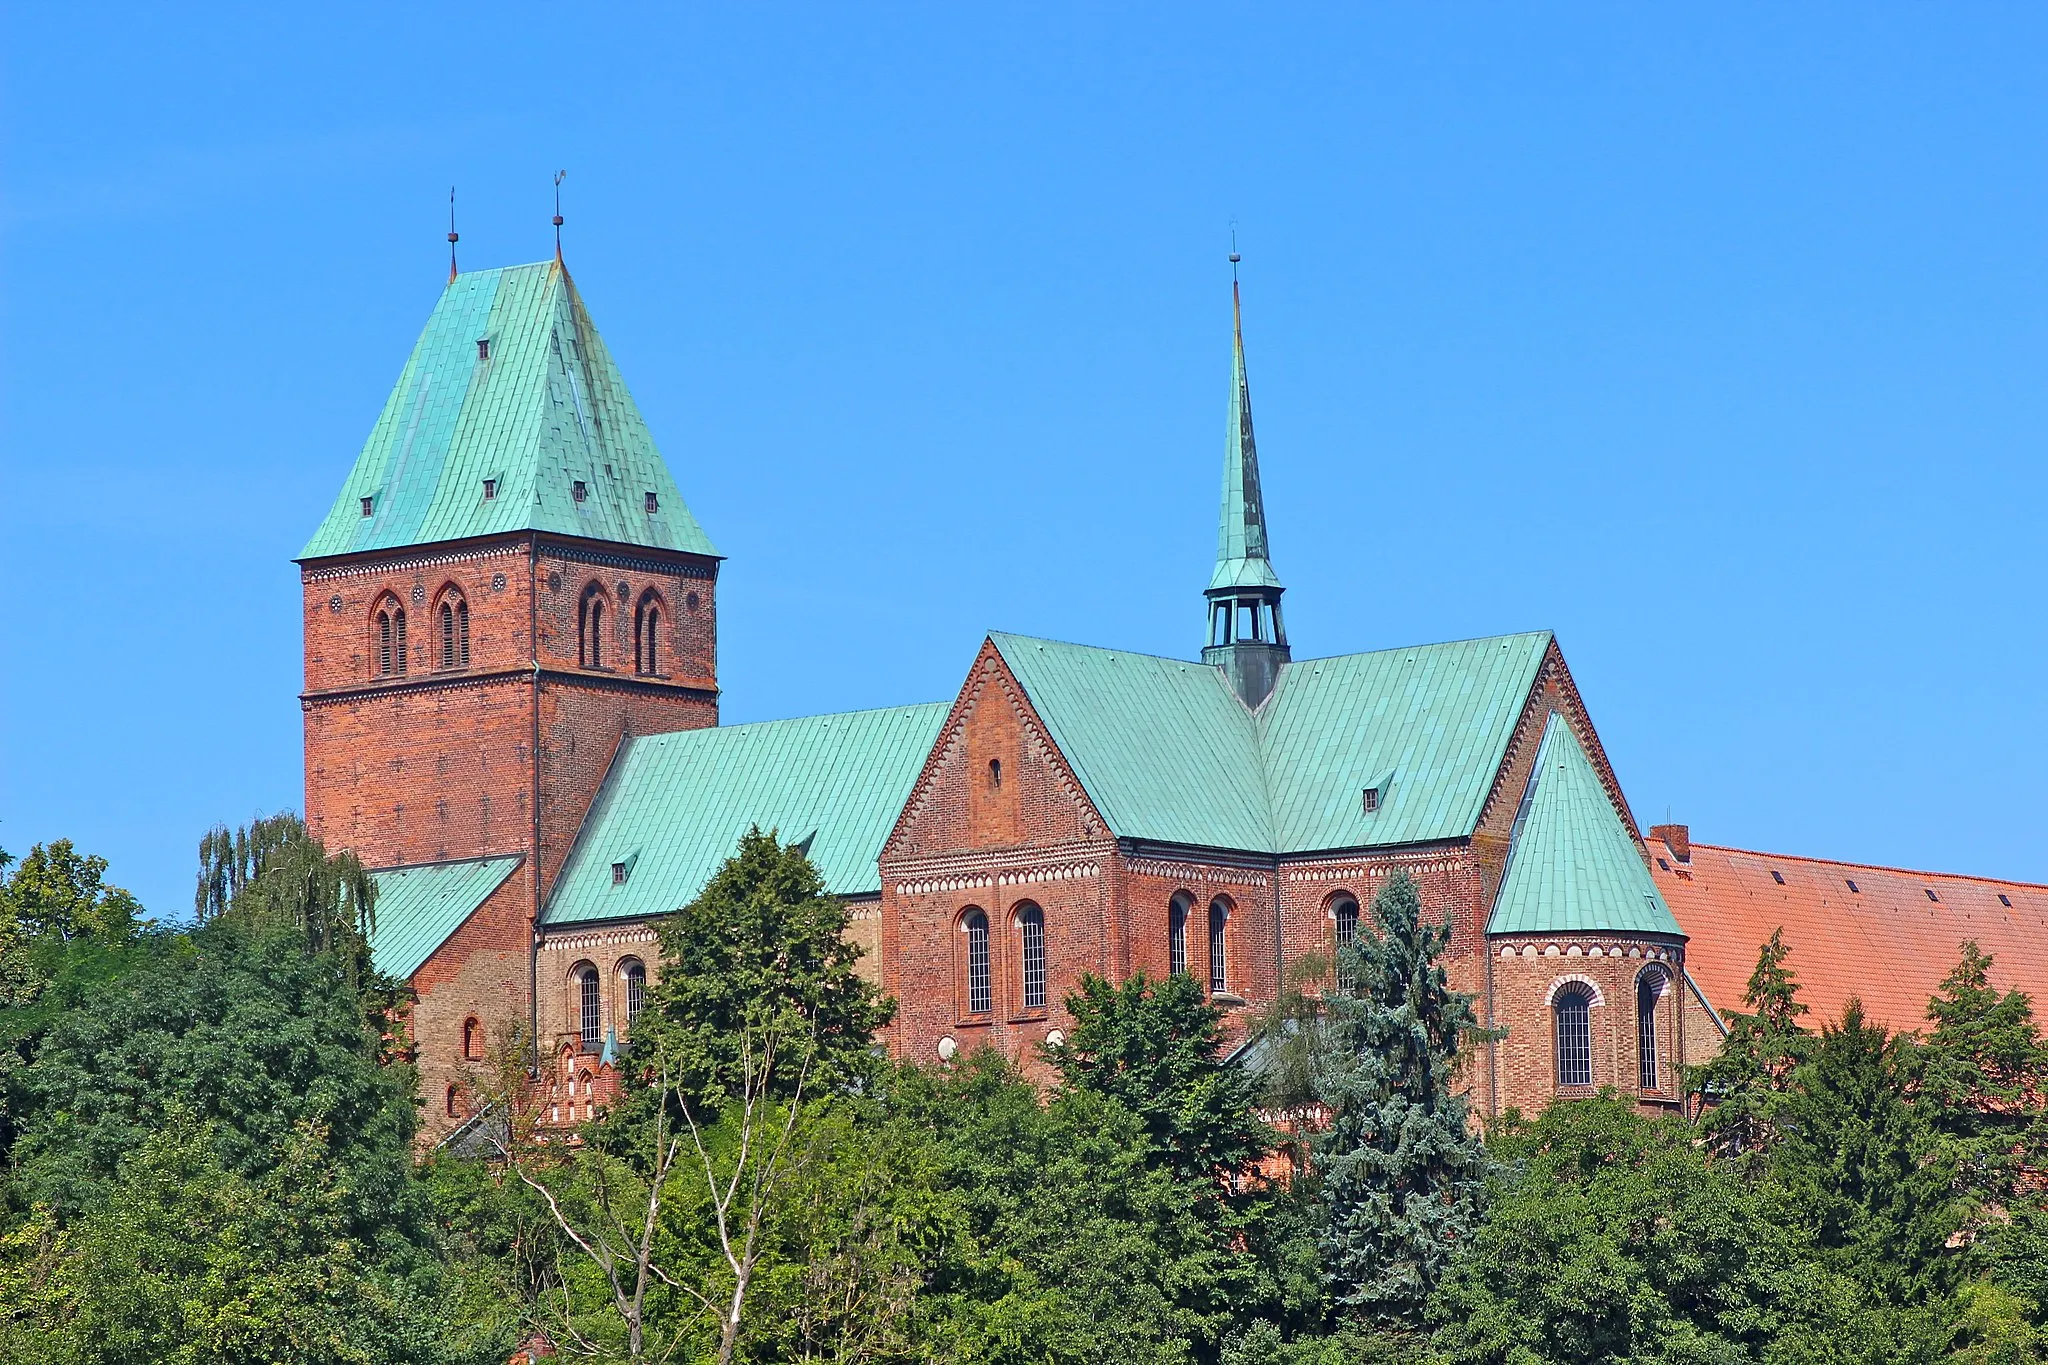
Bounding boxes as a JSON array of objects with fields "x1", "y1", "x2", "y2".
[{"x1": 1649, "y1": 837, "x2": 2048, "y2": 1029}]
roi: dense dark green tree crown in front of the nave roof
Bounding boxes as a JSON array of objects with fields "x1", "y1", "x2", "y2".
[{"x1": 633, "y1": 829, "x2": 895, "y2": 1111}]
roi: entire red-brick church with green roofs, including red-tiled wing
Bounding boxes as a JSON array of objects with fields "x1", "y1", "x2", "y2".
[{"x1": 297, "y1": 254, "x2": 2048, "y2": 1136}]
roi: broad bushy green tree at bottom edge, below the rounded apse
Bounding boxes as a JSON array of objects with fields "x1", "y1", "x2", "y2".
[{"x1": 1430, "y1": 1091, "x2": 1939, "y2": 1365}]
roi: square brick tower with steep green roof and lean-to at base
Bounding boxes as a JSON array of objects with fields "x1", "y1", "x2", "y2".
[{"x1": 299, "y1": 258, "x2": 719, "y2": 1113}]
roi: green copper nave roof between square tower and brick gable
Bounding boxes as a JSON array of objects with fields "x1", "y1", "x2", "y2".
[{"x1": 543, "y1": 702, "x2": 950, "y2": 925}]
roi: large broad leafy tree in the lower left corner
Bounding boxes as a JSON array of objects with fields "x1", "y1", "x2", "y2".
[{"x1": 0, "y1": 919, "x2": 442, "y2": 1361}]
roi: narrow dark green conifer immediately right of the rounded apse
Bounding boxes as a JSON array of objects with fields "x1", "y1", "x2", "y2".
[{"x1": 1694, "y1": 927, "x2": 1812, "y2": 1156}]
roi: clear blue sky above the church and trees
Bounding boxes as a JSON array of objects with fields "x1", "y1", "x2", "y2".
[{"x1": 0, "y1": 4, "x2": 2048, "y2": 915}]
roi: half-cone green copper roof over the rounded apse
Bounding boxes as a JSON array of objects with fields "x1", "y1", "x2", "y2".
[{"x1": 1487, "y1": 714, "x2": 1681, "y2": 935}]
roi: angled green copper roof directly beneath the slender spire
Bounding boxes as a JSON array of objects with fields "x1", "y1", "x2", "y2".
[{"x1": 989, "y1": 630, "x2": 1550, "y2": 853}]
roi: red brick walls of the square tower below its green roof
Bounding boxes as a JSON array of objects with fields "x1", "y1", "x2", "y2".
[{"x1": 301, "y1": 536, "x2": 719, "y2": 1136}]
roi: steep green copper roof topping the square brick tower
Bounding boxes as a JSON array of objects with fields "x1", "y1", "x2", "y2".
[{"x1": 299, "y1": 262, "x2": 717, "y2": 559}]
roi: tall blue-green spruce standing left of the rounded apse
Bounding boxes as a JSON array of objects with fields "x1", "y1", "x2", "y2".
[{"x1": 1315, "y1": 874, "x2": 1487, "y2": 1324}]
